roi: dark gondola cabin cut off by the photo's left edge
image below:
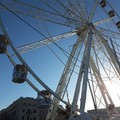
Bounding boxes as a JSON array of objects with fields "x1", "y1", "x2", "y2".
[{"x1": 0, "y1": 35, "x2": 9, "y2": 54}]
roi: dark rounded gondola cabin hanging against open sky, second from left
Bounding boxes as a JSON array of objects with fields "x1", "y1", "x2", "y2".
[{"x1": 12, "y1": 64, "x2": 28, "y2": 83}]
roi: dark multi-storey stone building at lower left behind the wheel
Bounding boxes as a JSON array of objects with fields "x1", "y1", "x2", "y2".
[{"x1": 0, "y1": 90, "x2": 51, "y2": 120}]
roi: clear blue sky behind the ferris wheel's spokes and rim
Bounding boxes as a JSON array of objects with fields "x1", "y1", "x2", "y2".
[{"x1": 0, "y1": 0, "x2": 120, "y2": 110}]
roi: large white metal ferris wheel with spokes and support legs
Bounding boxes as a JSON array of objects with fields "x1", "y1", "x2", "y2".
[{"x1": 0, "y1": 0, "x2": 120, "y2": 120}]
